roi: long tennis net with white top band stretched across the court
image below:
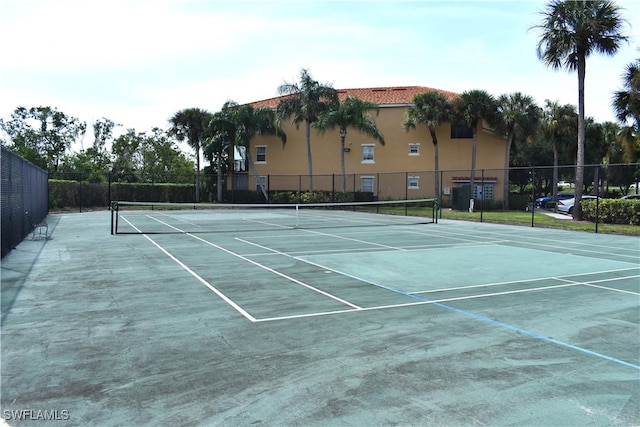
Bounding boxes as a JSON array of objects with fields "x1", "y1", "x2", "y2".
[{"x1": 111, "y1": 199, "x2": 438, "y2": 234}]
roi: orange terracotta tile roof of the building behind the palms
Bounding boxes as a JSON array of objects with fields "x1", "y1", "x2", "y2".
[{"x1": 250, "y1": 86, "x2": 460, "y2": 108}]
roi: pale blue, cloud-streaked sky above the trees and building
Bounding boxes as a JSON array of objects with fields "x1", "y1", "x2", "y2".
[{"x1": 0, "y1": 0, "x2": 640, "y2": 149}]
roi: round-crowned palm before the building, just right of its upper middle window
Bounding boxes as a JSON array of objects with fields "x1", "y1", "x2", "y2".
[{"x1": 402, "y1": 91, "x2": 453, "y2": 201}]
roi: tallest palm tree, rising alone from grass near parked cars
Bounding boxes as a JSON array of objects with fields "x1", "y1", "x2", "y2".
[{"x1": 534, "y1": 0, "x2": 627, "y2": 219}]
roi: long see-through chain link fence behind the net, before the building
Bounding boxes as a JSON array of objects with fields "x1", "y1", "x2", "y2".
[{"x1": 49, "y1": 163, "x2": 640, "y2": 211}]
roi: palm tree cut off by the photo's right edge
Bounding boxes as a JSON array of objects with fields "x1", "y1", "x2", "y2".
[{"x1": 613, "y1": 59, "x2": 640, "y2": 163}]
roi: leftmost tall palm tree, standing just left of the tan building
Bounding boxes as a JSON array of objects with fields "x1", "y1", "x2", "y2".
[{"x1": 169, "y1": 108, "x2": 211, "y2": 203}]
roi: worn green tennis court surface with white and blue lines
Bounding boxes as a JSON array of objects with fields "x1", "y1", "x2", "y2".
[{"x1": 1, "y1": 212, "x2": 640, "y2": 426}]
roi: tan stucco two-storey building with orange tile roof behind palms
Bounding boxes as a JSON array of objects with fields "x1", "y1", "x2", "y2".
[{"x1": 236, "y1": 86, "x2": 506, "y2": 202}]
